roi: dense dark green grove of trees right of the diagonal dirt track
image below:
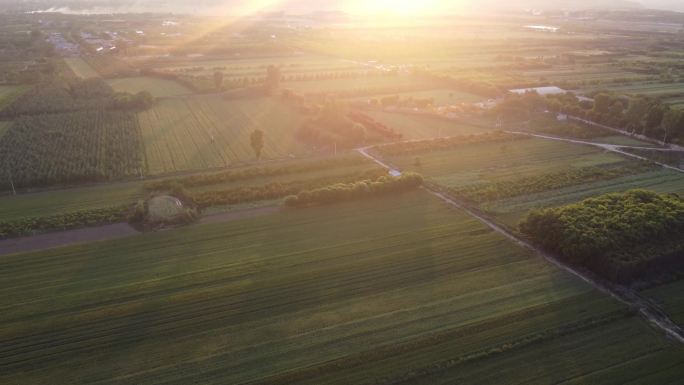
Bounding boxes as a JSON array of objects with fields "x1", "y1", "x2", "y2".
[{"x1": 520, "y1": 190, "x2": 684, "y2": 283}]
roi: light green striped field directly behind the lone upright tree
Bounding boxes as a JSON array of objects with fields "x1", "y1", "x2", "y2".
[{"x1": 138, "y1": 95, "x2": 303, "y2": 174}]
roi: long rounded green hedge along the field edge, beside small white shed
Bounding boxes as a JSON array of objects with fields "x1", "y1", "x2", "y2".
[{"x1": 284, "y1": 173, "x2": 423, "y2": 207}]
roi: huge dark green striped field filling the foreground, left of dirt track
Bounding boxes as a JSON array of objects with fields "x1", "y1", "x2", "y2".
[{"x1": 0, "y1": 191, "x2": 684, "y2": 384}]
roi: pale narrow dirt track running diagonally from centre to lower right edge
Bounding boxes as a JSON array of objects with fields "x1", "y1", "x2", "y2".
[{"x1": 357, "y1": 146, "x2": 684, "y2": 343}]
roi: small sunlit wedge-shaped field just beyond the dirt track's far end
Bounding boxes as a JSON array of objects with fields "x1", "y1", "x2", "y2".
[{"x1": 367, "y1": 111, "x2": 492, "y2": 139}]
